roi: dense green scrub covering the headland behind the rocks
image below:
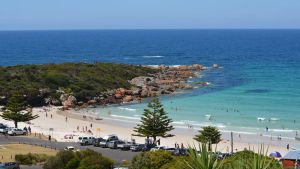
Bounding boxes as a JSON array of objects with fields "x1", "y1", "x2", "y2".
[{"x1": 0, "y1": 63, "x2": 158, "y2": 106}]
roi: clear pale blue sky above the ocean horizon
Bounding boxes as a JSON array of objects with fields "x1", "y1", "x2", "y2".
[{"x1": 0, "y1": 0, "x2": 300, "y2": 30}]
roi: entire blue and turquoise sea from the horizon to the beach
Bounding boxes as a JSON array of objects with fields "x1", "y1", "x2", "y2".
[{"x1": 0, "y1": 30, "x2": 300, "y2": 139}]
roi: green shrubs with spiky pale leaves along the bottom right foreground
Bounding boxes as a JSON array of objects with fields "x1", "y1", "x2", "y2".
[{"x1": 129, "y1": 144, "x2": 282, "y2": 169}]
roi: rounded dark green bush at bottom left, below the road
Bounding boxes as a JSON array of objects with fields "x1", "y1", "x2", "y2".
[{"x1": 43, "y1": 149, "x2": 114, "y2": 169}]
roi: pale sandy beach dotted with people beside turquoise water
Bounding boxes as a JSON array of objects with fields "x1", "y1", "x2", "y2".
[{"x1": 0, "y1": 107, "x2": 296, "y2": 155}]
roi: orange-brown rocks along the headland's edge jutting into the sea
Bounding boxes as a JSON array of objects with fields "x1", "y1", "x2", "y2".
[{"x1": 60, "y1": 64, "x2": 218, "y2": 109}]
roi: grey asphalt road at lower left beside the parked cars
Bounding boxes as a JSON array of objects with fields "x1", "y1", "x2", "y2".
[{"x1": 0, "y1": 135, "x2": 138, "y2": 164}]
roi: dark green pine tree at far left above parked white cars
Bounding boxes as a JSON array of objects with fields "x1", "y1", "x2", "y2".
[{"x1": 0, "y1": 94, "x2": 39, "y2": 128}]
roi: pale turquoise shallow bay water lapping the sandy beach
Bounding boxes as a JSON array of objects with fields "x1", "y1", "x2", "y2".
[{"x1": 88, "y1": 61, "x2": 300, "y2": 138}]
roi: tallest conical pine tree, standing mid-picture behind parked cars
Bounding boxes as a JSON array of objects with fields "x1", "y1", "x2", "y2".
[{"x1": 133, "y1": 97, "x2": 174, "y2": 142}]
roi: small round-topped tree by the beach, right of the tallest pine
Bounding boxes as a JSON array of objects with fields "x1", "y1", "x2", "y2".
[{"x1": 194, "y1": 126, "x2": 221, "y2": 151}]
